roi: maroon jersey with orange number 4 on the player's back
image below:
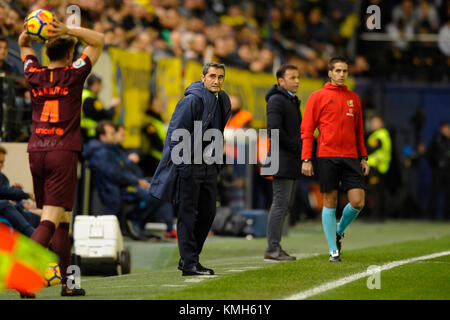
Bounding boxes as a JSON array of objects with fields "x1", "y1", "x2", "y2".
[{"x1": 24, "y1": 54, "x2": 92, "y2": 152}]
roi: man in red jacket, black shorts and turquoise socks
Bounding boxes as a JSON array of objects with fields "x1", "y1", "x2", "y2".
[{"x1": 301, "y1": 57, "x2": 369, "y2": 262}]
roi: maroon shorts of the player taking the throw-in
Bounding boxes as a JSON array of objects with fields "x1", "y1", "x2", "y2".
[{"x1": 29, "y1": 151, "x2": 78, "y2": 211}]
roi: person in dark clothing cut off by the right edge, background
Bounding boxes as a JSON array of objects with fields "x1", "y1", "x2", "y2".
[{"x1": 427, "y1": 122, "x2": 450, "y2": 219}]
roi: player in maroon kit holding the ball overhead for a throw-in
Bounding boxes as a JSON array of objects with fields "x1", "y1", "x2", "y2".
[{"x1": 19, "y1": 21, "x2": 104, "y2": 297}]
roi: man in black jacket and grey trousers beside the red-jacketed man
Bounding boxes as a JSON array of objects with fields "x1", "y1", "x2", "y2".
[{"x1": 264, "y1": 65, "x2": 302, "y2": 262}]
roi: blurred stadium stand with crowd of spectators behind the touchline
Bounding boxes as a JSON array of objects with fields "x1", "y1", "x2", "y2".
[{"x1": 0, "y1": 0, "x2": 450, "y2": 222}]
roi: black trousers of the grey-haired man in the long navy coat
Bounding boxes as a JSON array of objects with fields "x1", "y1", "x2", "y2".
[{"x1": 177, "y1": 165, "x2": 217, "y2": 268}]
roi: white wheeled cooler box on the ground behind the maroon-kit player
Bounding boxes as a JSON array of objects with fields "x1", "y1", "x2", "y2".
[{"x1": 72, "y1": 215, "x2": 130, "y2": 274}]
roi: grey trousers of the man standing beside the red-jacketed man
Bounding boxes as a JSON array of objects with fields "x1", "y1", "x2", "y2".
[{"x1": 266, "y1": 177, "x2": 296, "y2": 254}]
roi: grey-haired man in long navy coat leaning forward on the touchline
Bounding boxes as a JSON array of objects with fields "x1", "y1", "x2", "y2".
[{"x1": 150, "y1": 62, "x2": 231, "y2": 276}]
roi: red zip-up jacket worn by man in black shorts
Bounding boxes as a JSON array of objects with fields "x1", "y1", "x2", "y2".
[{"x1": 301, "y1": 82, "x2": 367, "y2": 160}]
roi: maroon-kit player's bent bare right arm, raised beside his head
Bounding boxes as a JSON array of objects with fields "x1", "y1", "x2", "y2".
[{"x1": 48, "y1": 20, "x2": 104, "y2": 65}]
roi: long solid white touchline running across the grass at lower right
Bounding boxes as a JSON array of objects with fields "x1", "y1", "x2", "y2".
[{"x1": 284, "y1": 251, "x2": 450, "y2": 300}]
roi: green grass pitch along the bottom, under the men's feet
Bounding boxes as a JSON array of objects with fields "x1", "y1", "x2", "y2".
[{"x1": 0, "y1": 221, "x2": 450, "y2": 300}]
